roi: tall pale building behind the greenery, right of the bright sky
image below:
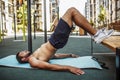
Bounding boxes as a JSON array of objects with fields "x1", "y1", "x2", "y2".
[{"x1": 85, "y1": 0, "x2": 120, "y2": 28}]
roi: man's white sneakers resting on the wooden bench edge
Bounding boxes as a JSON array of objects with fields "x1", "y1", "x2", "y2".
[{"x1": 93, "y1": 29, "x2": 114, "y2": 43}]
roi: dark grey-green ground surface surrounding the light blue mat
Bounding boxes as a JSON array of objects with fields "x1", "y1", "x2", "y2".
[{"x1": 0, "y1": 34, "x2": 115, "y2": 80}]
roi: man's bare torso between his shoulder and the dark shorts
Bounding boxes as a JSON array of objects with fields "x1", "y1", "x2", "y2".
[{"x1": 32, "y1": 41, "x2": 56, "y2": 61}]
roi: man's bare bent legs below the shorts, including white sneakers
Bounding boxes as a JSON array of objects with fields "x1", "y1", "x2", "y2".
[{"x1": 62, "y1": 8, "x2": 114, "y2": 43}]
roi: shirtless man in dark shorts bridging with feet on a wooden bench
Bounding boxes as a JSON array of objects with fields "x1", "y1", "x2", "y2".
[{"x1": 16, "y1": 7, "x2": 113, "y2": 75}]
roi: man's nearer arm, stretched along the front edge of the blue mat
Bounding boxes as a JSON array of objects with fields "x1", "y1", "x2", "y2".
[{"x1": 29, "y1": 57, "x2": 84, "y2": 75}]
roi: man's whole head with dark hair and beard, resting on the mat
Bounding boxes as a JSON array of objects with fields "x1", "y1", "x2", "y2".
[{"x1": 16, "y1": 50, "x2": 30, "y2": 63}]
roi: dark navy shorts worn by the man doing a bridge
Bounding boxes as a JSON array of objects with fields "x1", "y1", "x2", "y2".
[{"x1": 49, "y1": 18, "x2": 72, "y2": 49}]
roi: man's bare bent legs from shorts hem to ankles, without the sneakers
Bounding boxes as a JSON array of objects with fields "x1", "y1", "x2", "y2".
[{"x1": 62, "y1": 7, "x2": 97, "y2": 35}]
